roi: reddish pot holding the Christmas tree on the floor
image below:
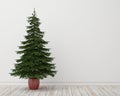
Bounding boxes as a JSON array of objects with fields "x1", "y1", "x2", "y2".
[{"x1": 28, "y1": 78, "x2": 40, "y2": 90}]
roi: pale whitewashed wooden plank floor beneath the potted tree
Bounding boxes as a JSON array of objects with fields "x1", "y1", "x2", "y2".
[{"x1": 0, "y1": 85, "x2": 120, "y2": 96}]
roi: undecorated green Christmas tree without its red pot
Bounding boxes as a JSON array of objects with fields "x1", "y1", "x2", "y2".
[{"x1": 10, "y1": 10, "x2": 56, "y2": 79}]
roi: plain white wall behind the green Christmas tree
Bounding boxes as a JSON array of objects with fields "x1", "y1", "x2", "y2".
[{"x1": 0, "y1": 0, "x2": 120, "y2": 82}]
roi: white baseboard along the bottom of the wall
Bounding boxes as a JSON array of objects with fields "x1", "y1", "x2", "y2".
[{"x1": 0, "y1": 82, "x2": 120, "y2": 85}]
